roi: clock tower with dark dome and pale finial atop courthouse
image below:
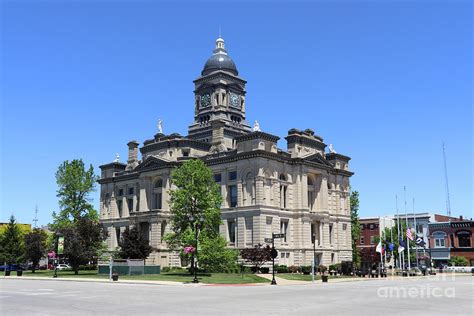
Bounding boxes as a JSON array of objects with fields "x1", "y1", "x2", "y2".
[{"x1": 188, "y1": 37, "x2": 251, "y2": 151}]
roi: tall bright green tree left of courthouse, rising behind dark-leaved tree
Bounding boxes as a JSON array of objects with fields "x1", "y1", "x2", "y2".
[{"x1": 51, "y1": 159, "x2": 98, "y2": 231}]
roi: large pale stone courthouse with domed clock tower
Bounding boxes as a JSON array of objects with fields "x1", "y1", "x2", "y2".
[{"x1": 99, "y1": 38, "x2": 353, "y2": 266}]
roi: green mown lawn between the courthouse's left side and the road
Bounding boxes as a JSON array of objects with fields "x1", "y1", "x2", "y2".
[{"x1": 20, "y1": 270, "x2": 268, "y2": 284}]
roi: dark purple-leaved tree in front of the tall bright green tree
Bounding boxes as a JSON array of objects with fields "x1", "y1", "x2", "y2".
[{"x1": 59, "y1": 217, "x2": 107, "y2": 274}]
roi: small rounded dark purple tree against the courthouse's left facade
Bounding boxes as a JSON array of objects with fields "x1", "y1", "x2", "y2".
[{"x1": 118, "y1": 226, "x2": 152, "y2": 259}]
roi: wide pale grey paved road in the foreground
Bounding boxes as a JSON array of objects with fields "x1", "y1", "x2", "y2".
[{"x1": 0, "y1": 276, "x2": 474, "y2": 316}]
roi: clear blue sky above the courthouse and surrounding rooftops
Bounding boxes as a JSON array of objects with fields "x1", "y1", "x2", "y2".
[{"x1": 0, "y1": 1, "x2": 473, "y2": 224}]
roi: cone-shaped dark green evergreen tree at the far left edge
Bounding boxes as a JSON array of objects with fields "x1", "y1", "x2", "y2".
[{"x1": 0, "y1": 215, "x2": 25, "y2": 264}]
